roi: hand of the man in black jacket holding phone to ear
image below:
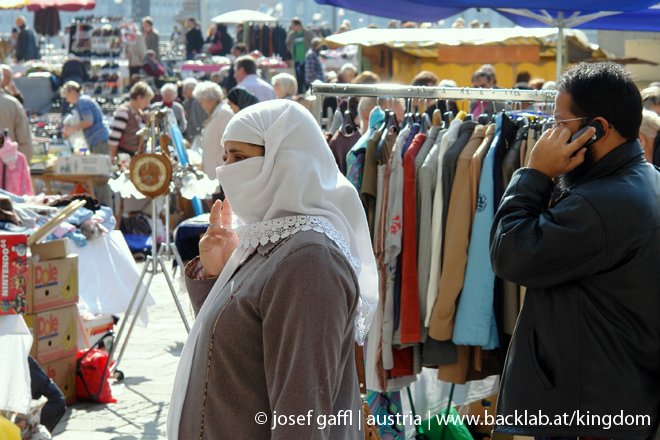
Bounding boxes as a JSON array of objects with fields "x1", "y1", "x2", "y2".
[{"x1": 529, "y1": 127, "x2": 596, "y2": 178}]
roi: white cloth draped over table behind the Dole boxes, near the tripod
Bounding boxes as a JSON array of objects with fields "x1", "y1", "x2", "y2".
[{"x1": 71, "y1": 231, "x2": 156, "y2": 324}]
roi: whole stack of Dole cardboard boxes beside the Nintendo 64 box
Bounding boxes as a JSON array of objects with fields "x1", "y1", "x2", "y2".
[{"x1": 24, "y1": 239, "x2": 79, "y2": 404}]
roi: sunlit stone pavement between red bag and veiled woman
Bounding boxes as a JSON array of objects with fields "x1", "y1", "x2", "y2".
[{"x1": 53, "y1": 263, "x2": 192, "y2": 440}]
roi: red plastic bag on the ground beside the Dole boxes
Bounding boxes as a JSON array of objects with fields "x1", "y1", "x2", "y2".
[{"x1": 76, "y1": 348, "x2": 117, "y2": 403}]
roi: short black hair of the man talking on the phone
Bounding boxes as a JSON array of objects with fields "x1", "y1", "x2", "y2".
[{"x1": 557, "y1": 62, "x2": 642, "y2": 141}]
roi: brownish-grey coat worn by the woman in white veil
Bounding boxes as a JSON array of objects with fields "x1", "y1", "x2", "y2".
[{"x1": 179, "y1": 231, "x2": 364, "y2": 440}]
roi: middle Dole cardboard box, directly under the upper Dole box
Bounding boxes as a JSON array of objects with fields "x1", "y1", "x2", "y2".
[{"x1": 24, "y1": 304, "x2": 78, "y2": 363}]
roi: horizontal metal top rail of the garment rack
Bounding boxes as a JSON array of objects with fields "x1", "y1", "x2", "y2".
[{"x1": 311, "y1": 83, "x2": 557, "y2": 124}]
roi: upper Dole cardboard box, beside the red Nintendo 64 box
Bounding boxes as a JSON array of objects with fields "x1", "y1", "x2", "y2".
[{"x1": 26, "y1": 254, "x2": 78, "y2": 313}]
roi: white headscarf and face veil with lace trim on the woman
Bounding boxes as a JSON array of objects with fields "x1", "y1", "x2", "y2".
[{"x1": 167, "y1": 99, "x2": 378, "y2": 440}]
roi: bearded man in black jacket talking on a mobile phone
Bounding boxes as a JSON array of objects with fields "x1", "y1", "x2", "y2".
[{"x1": 490, "y1": 63, "x2": 660, "y2": 440}]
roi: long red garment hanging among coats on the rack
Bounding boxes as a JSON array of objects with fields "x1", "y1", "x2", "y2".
[{"x1": 400, "y1": 134, "x2": 426, "y2": 344}]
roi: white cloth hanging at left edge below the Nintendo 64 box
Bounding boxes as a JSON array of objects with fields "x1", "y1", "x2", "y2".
[{"x1": 0, "y1": 315, "x2": 32, "y2": 414}]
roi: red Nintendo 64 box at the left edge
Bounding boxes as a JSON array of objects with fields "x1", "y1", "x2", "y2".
[{"x1": 0, "y1": 233, "x2": 28, "y2": 315}]
